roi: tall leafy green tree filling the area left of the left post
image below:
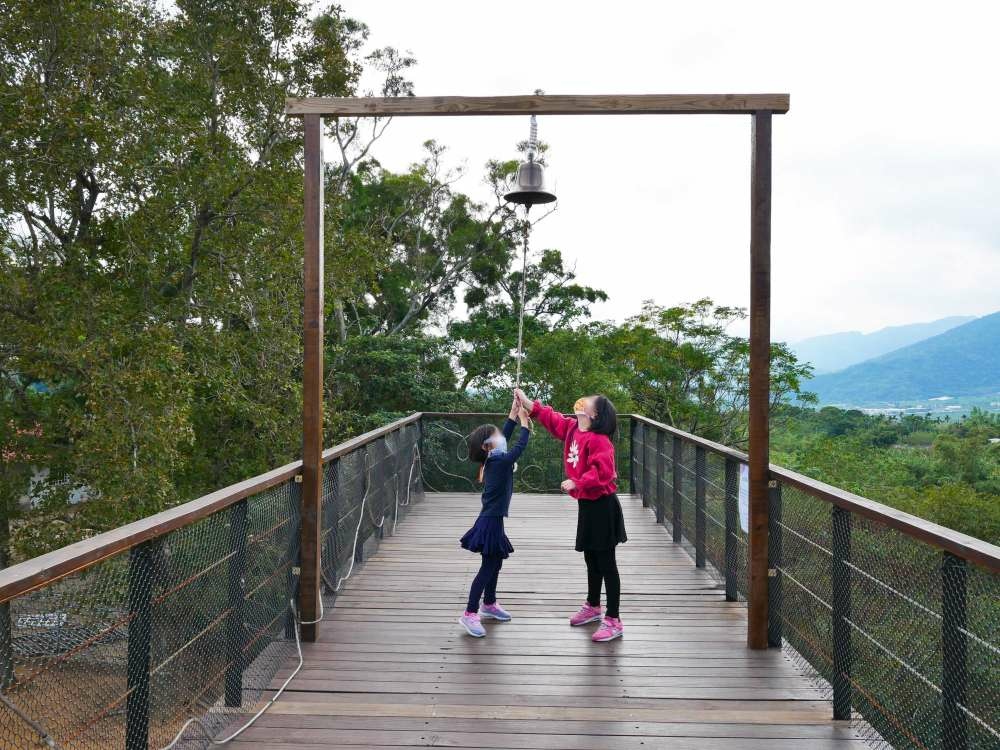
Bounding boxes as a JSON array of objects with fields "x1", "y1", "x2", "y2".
[{"x1": 0, "y1": 0, "x2": 410, "y2": 554}]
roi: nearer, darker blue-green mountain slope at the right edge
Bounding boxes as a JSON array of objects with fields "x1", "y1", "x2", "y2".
[{"x1": 805, "y1": 312, "x2": 1000, "y2": 406}]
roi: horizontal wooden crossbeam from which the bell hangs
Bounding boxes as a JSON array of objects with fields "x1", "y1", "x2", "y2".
[{"x1": 285, "y1": 94, "x2": 789, "y2": 117}]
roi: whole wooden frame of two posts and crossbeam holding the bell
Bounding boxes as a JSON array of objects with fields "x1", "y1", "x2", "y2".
[{"x1": 285, "y1": 94, "x2": 789, "y2": 649}]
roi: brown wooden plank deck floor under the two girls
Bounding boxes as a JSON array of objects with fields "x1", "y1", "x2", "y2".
[{"x1": 231, "y1": 494, "x2": 865, "y2": 750}]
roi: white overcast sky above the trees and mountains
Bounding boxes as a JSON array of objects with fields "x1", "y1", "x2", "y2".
[{"x1": 342, "y1": 0, "x2": 1000, "y2": 341}]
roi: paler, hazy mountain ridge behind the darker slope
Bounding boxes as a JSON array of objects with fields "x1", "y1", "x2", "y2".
[{"x1": 791, "y1": 315, "x2": 975, "y2": 375}]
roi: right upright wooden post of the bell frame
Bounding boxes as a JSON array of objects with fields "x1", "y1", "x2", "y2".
[{"x1": 747, "y1": 112, "x2": 771, "y2": 649}]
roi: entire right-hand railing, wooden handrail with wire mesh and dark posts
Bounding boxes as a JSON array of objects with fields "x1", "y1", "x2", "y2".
[{"x1": 630, "y1": 415, "x2": 1000, "y2": 750}]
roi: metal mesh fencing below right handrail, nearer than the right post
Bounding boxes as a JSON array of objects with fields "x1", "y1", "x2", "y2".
[{"x1": 771, "y1": 485, "x2": 1000, "y2": 748}]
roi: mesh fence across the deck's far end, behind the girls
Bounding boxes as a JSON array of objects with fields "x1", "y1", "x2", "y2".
[{"x1": 421, "y1": 414, "x2": 631, "y2": 493}]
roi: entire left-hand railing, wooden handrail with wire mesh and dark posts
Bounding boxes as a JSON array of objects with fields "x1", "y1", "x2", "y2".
[{"x1": 0, "y1": 415, "x2": 423, "y2": 750}]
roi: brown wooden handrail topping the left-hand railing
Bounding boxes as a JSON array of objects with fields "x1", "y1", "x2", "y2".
[{"x1": 0, "y1": 412, "x2": 421, "y2": 603}]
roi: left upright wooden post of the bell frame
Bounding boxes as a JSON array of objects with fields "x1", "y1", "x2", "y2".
[{"x1": 299, "y1": 115, "x2": 323, "y2": 641}]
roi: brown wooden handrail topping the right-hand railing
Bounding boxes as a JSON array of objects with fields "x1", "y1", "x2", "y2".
[{"x1": 629, "y1": 414, "x2": 1000, "y2": 573}]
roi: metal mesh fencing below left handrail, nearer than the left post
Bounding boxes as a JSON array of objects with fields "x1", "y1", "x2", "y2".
[{"x1": 0, "y1": 481, "x2": 299, "y2": 749}]
